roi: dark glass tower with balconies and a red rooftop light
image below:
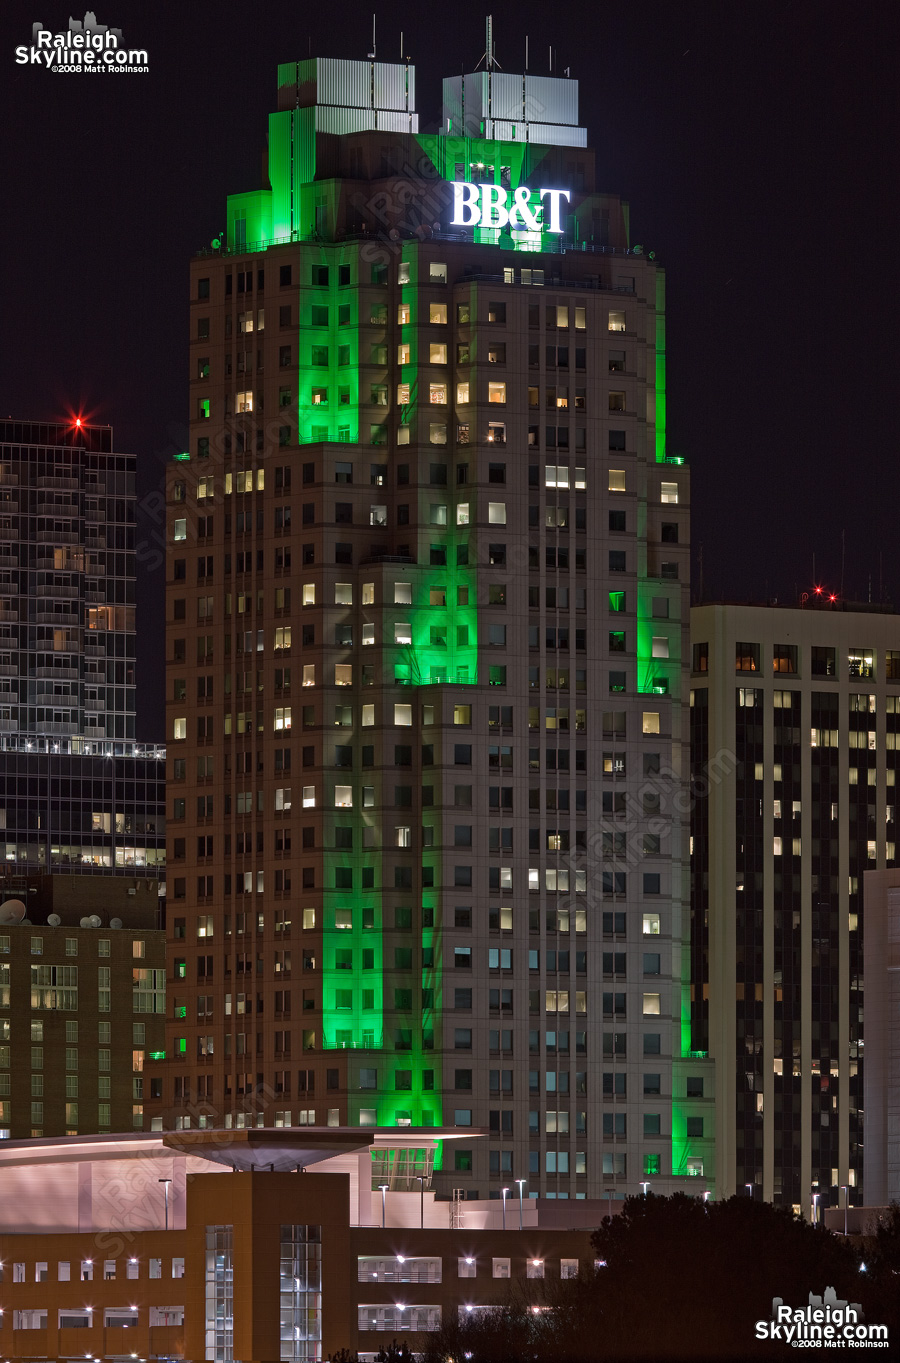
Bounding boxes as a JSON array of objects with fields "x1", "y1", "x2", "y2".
[{"x1": 0, "y1": 418, "x2": 165, "y2": 877}]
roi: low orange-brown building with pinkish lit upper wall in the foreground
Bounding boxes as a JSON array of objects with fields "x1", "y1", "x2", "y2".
[{"x1": 0, "y1": 1129, "x2": 607, "y2": 1363}]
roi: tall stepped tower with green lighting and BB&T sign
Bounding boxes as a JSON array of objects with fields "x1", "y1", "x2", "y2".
[{"x1": 155, "y1": 60, "x2": 712, "y2": 1197}]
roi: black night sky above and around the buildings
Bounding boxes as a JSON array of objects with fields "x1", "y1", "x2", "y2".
[{"x1": 0, "y1": 0, "x2": 900, "y2": 737}]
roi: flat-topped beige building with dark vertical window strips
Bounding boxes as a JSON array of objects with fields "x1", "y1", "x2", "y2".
[{"x1": 690, "y1": 597, "x2": 900, "y2": 1214}]
